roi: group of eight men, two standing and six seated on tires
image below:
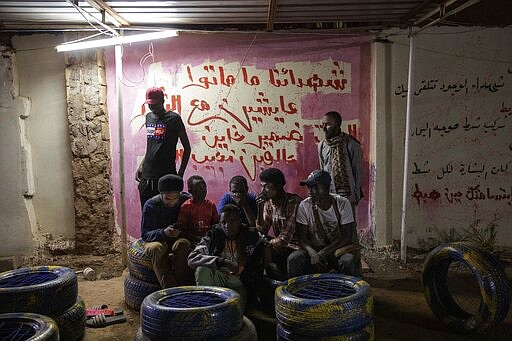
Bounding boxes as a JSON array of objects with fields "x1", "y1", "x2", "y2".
[{"x1": 136, "y1": 88, "x2": 362, "y2": 307}]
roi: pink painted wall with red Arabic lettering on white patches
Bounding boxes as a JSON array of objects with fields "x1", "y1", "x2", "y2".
[{"x1": 106, "y1": 33, "x2": 371, "y2": 238}]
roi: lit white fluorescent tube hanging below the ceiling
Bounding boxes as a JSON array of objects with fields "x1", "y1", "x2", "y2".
[{"x1": 55, "y1": 30, "x2": 178, "y2": 52}]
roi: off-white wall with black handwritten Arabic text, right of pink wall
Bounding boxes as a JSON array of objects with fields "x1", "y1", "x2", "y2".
[{"x1": 388, "y1": 28, "x2": 512, "y2": 246}]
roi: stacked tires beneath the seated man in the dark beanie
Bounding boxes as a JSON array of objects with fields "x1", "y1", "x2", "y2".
[{"x1": 124, "y1": 239, "x2": 161, "y2": 310}]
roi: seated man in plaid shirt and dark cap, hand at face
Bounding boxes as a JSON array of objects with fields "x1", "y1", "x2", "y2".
[{"x1": 256, "y1": 168, "x2": 302, "y2": 280}]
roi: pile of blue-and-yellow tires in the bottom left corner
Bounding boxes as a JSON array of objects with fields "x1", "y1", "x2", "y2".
[{"x1": 0, "y1": 266, "x2": 86, "y2": 341}]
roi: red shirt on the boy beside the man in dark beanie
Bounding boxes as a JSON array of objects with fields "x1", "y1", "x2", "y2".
[{"x1": 178, "y1": 198, "x2": 219, "y2": 241}]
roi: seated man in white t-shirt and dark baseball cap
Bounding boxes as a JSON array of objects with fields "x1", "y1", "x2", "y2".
[{"x1": 288, "y1": 170, "x2": 361, "y2": 277}]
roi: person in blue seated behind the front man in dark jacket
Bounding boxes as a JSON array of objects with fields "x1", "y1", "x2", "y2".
[{"x1": 217, "y1": 175, "x2": 258, "y2": 226}]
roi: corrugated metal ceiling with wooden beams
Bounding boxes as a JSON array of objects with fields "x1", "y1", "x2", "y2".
[{"x1": 0, "y1": 0, "x2": 512, "y2": 32}]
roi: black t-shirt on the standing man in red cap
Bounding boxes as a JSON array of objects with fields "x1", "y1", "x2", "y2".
[{"x1": 142, "y1": 111, "x2": 185, "y2": 179}]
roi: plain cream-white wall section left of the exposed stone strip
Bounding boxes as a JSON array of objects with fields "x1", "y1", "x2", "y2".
[{"x1": 0, "y1": 34, "x2": 75, "y2": 256}]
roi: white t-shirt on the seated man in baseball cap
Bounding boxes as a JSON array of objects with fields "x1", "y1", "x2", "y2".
[{"x1": 296, "y1": 194, "x2": 357, "y2": 246}]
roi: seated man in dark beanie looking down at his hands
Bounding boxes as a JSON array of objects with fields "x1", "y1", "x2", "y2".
[{"x1": 142, "y1": 174, "x2": 191, "y2": 288}]
